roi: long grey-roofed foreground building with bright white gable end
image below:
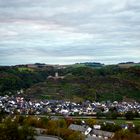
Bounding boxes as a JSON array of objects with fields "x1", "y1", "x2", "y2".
[{"x1": 69, "y1": 124, "x2": 92, "y2": 135}]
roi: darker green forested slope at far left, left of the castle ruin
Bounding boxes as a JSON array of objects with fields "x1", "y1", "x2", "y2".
[{"x1": 0, "y1": 66, "x2": 54, "y2": 94}]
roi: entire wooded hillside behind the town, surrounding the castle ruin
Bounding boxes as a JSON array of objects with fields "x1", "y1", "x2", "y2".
[{"x1": 0, "y1": 65, "x2": 140, "y2": 101}]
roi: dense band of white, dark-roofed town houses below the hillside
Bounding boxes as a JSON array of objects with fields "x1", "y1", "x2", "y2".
[{"x1": 0, "y1": 95, "x2": 140, "y2": 116}]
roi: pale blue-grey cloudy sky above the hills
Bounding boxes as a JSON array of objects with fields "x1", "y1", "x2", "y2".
[{"x1": 0, "y1": 0, "x2": 140, "y2": 65}]
